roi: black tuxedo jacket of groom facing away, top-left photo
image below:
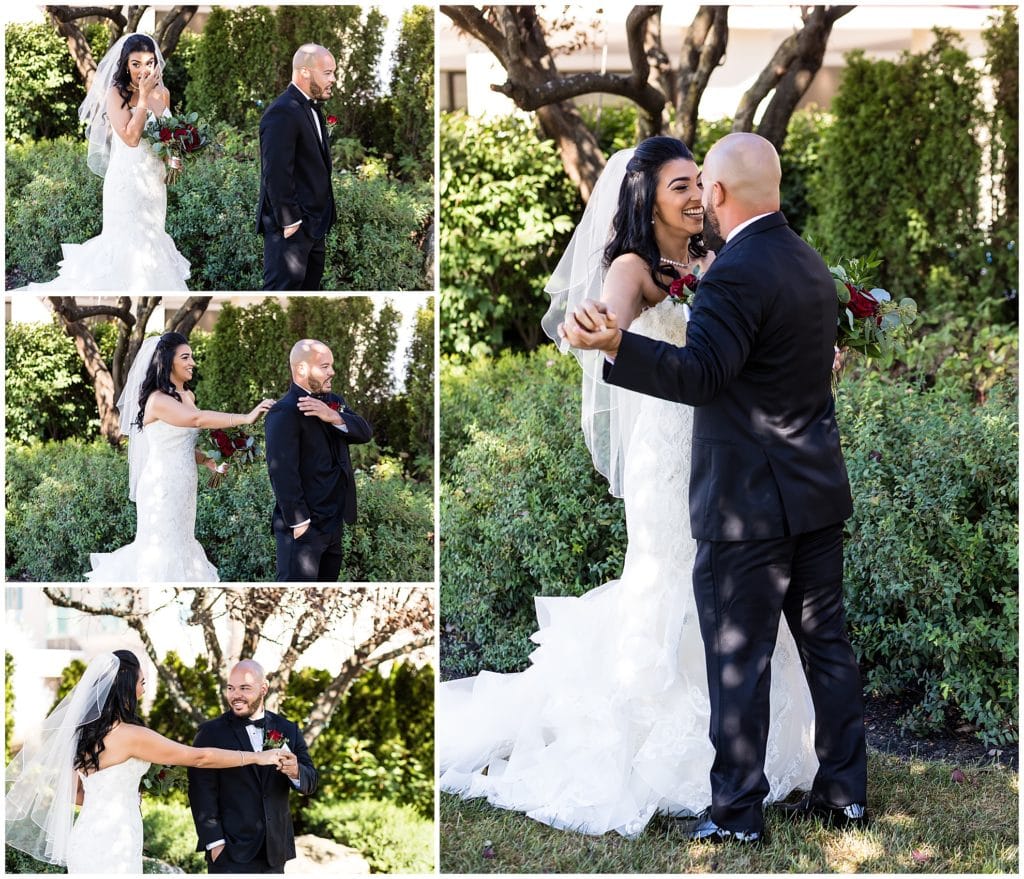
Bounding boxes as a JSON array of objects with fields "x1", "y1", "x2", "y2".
[{"x1": 256, "y1": 85, "x2": 337, "y2": 239}]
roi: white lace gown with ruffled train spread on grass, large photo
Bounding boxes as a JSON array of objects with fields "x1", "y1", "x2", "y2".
[{"x1": 437, "y1": 299, "x2": 817, "y2": 837}]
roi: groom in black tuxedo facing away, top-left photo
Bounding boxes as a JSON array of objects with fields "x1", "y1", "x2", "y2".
[{"x1": 256, "y1": 43, "x2": 337, "y2": 290}]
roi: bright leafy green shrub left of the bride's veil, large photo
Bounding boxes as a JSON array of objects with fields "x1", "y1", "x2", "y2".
[{"x1": 439, "y1": 114, "x2": 582, "y2": 357}]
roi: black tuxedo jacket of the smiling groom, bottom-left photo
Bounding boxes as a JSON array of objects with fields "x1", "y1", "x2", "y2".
[{"x1": 188, "y1": 711, "x2": 318, "y2": 866}]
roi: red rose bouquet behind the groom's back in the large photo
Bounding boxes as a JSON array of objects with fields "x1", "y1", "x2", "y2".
[{"x1": 828, "y1": 255, "x2": 918, "y2": 367}]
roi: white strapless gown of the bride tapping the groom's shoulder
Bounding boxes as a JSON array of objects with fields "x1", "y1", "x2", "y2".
[{"x1": 86, "y1": 421, "x2": 218, "y2": 583}]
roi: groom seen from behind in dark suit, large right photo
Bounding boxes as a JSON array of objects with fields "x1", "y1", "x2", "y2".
[{"x1": 562, "y1": 133, "x2": 867, "y2": 843}]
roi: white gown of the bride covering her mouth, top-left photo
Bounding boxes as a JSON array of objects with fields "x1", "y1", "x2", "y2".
[{"x1": 23, "y1": 108, "x2": 189, "y2": 293}]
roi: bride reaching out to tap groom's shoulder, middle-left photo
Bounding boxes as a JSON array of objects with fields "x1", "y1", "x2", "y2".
[{"x1": 86, "y1": 333, "x2": 274, "y2": 583}]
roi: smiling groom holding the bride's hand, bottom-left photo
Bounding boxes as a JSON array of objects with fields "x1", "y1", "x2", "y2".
[{"x1": 188, "y1": 660, "x2": 318, "y2": 873}]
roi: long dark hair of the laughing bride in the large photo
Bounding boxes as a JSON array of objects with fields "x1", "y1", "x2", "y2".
[{"x1": 604, "y1": 136, "x2": 708, "y2": 290}]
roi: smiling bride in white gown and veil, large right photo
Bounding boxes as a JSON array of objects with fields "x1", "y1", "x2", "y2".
[{"x1": 437, "y1": 137, "x2": 817, "y2": 837}]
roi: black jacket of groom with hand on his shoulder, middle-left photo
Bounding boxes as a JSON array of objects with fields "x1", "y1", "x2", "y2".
[{"x1": 266, "y1": 383, "x2": 374, "y2": 532}]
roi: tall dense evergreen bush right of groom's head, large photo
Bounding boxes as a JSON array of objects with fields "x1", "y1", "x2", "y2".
[{"x1": 808, "y1": 32, "x2": 987, "y2": 311}]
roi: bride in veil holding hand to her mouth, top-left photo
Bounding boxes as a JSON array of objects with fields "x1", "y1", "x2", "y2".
[{"x1": 23, "y1": 34, "x2": 189, "y2": 292}]
